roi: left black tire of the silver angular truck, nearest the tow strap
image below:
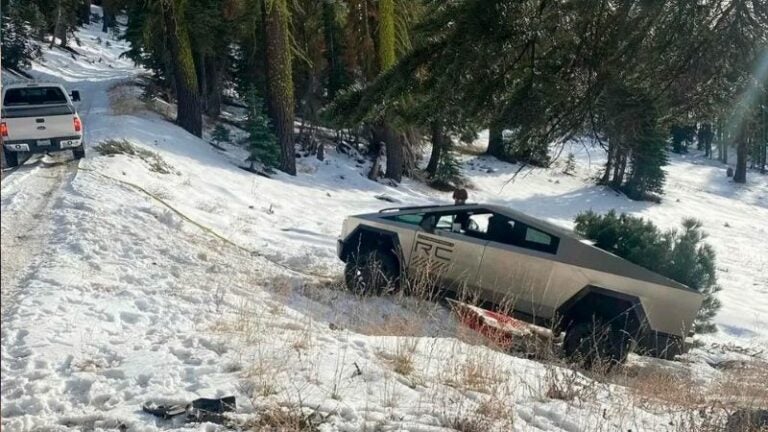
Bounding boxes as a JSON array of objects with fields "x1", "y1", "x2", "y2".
[{"x1": 344, "y1": 250, "x2": 400, "y2": 295}]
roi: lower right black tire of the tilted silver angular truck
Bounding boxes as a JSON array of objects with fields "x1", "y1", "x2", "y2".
[{"x1": 563, "y1": 321, "x2": 630, "y2": 369}]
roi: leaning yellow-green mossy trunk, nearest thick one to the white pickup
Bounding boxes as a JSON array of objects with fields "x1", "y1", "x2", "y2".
[{"x1": 163, "y1": 0, "x2": 203, "y2": 137}]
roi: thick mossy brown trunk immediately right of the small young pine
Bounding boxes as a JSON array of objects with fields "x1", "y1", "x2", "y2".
[{"x1": 262, "y1": 0, "x2": 296, "y2": 175}]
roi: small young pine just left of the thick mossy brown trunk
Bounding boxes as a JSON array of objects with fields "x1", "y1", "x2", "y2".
[{"x1": 246, "y1": 89, "x2": 280, "y2": 170}]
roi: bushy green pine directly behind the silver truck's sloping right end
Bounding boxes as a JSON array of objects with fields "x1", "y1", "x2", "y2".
[{"x1": 575, "y1": 210, "x2": 720, "y2": 333}]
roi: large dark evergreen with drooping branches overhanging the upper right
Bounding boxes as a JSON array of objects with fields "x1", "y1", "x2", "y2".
[{"x1": 334, "y1": 0, "x2": 768, "y2": 196}]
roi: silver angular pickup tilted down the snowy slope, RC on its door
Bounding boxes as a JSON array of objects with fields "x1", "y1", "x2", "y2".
[{"x1": 338, "y1": 204, "x2": 703, "y2": 362}]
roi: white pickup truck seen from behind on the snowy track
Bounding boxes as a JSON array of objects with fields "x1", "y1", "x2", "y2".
[{"x1": 0, "y1": 83, "x2": 85, "y2": 167}]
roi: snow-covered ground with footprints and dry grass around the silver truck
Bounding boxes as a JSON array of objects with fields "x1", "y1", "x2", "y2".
[{"x1": 0, "y1": 10, "x2": 768, "y2": 431}]
